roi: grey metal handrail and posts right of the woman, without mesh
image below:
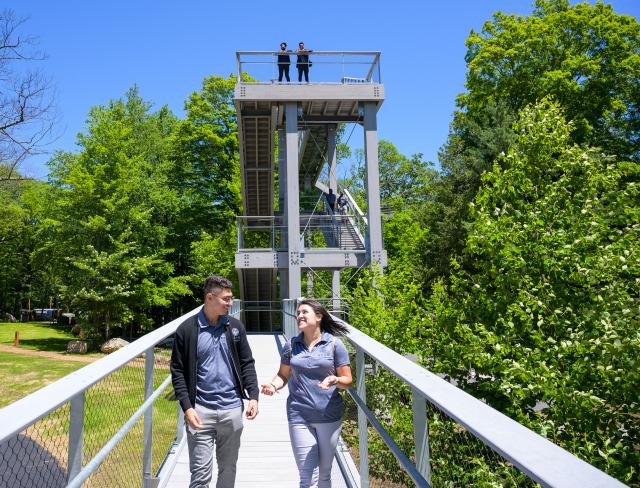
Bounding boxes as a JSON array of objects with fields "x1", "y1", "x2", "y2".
[{"x1": 282, "y1": 300, "x2": 625, "y2": 488}]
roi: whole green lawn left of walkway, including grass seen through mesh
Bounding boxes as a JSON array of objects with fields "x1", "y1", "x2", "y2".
[{"x1": 0, "y1": 346, "x2": 177, "y2": 488}]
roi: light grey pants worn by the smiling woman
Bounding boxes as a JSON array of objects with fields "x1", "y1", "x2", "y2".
[{"x1": 289, "y1": 420, "x2": 342, "y2": 488}]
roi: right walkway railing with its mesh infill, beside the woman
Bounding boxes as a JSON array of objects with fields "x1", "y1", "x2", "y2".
[{"x1": 282, "y1": 300, "x2": 624, "y2": 488}]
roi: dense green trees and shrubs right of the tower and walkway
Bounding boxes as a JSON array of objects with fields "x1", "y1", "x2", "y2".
[{"x1": 340, "y1": 0, "x2": 640, "y2": 486}]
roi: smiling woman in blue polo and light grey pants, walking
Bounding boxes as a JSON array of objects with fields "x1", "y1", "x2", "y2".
[{"x1": 261, "y1": 300, "x2": 353, "y2": 488}]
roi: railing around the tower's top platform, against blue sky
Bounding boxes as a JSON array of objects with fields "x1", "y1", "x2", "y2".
[{"x1": 236, "y1": 51, "x2": 382, "y2": 84}]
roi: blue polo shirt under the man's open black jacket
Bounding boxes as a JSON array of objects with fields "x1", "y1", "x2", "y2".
[{"x1": 196, "y1": 307, "x2": 242, "y2": 410}]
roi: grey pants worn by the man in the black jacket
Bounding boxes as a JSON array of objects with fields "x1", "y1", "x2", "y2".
[{"x1": 187, "y1": 405, "x2": 243, "y2": 488}]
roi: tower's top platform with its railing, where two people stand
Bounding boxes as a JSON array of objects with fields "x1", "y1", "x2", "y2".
[{"x1": 235, "y1": 51, "x2": 384, "y2": 106}]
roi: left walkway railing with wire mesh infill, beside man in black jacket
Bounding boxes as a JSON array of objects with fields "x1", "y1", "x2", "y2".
[{"x1": 0, "y1": 300, "x2": 240, "y2": 488}]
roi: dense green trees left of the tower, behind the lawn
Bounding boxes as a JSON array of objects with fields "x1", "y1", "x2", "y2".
[{"x1": 0, "y1": 77, "x2": 240, "y2": 336}]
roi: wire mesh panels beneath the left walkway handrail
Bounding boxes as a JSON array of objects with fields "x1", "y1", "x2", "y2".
[{"x1": 0, "y1": 348, "x2": 177, "y2": 488}]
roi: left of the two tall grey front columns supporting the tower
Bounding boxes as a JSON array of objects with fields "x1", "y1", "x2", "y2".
[{"x1": 285, "y1": 102, "x2": 302, "y2": 298}]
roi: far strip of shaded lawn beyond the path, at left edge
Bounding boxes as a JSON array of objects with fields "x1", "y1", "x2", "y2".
[{"x1": 0, "y1": 322, "x2": 77, "y2": 352}]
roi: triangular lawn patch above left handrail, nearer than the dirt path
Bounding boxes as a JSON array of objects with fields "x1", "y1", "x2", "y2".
[{"x1": 0, "y1": 352, "x2": 86, "y2": 408}]
